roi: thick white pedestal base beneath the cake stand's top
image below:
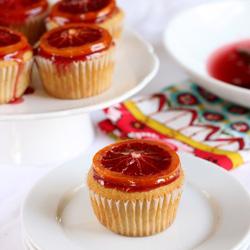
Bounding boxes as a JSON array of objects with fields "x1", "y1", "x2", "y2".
[{"x1": 0, "y1": 113, "x2": 94, "y2": 165}]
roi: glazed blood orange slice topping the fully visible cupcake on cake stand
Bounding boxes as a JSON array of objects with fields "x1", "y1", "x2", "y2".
[{"x1": 40, "y1": 24, "x2": 112, "y2": 57}]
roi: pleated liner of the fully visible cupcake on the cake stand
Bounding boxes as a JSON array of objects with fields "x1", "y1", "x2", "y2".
[{"x1": 36, "y1": 47, "x2": 116, "y2": 99}]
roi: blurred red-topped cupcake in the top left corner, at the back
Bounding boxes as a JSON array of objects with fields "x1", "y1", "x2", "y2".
[{"x1": 0, "y1": 0, "x2": 48, "y2": 45}]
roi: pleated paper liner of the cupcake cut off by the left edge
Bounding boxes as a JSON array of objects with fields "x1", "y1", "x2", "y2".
[{"x1": 0, "y1": 58, "x2": 33, "y2": 104}]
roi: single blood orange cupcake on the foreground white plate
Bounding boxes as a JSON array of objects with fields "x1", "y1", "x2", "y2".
[{"x1": 87, "y1": 140, "x2": 185, "y2": 236}]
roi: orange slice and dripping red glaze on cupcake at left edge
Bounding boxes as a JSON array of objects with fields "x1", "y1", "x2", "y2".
[{"x1": 0, "y1": 27, "x2": 32, "y2": 99}]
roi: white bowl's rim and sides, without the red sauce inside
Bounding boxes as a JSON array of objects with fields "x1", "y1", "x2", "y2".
[{"x1": 164, "y1": 0, "x2": 250, "y2": 108}]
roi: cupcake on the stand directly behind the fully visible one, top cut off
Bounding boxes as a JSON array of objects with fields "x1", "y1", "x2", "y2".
[{"x1": 46, "y1": 0, "x2": 124, "y2": 40}]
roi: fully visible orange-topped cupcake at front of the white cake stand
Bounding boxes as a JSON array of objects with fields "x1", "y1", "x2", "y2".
[{"x1": 35, "y1": 23, "x2": 116, "y2": 99}]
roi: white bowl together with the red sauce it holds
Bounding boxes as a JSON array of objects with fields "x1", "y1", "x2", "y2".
[{"x1": 164, "y1": 0, "x2": 250, "y2": 108}]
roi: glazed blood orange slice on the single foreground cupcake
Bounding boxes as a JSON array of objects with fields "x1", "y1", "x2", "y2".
[{"x1": 93, "y1": 139, "x2": 181, "y2": 189}]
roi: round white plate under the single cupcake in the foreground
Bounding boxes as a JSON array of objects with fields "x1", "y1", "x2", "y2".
[{"x1": 21, "y1": 154, "x2": 250, "y2": 250}]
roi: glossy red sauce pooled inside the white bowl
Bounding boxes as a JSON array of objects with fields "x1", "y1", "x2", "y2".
[{"x1": 207, "y1": 40, "x2": 250, "y2": 89}]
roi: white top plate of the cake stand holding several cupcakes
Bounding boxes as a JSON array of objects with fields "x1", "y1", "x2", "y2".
[{"x1": 0, "y1": 28, "x2": 159, "y2": 120}]
